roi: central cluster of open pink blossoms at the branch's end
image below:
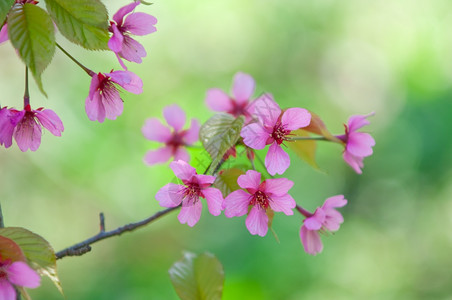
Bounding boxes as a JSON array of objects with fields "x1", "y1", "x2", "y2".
[{"x1": 147, "y1": 72, "x2": 375, "y2": 255}]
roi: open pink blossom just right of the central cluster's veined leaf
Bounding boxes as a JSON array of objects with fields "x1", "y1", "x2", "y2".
[{"x1": 240, "y1": 94, "x2": 311, "y2": 175}]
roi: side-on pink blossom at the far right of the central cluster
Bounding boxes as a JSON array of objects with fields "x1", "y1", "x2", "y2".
[{"x1": 337, "y1": 113, "x2": 375, "y2": 174}]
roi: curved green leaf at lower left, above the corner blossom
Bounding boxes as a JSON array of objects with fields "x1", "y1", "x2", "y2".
[{"x1": 0, "y1": 227, "x2": 63, "y2": 293}]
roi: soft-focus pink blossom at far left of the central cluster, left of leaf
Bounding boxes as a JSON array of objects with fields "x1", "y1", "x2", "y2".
[{"x1": 141, "y1": 104, "x2": 200, "y2": 165}]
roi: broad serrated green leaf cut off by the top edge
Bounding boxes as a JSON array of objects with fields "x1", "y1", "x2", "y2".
[{"x1": 45, "y1": 0, "x2": 109, "y2": 50}]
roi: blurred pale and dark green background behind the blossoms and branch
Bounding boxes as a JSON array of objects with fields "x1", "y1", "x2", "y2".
[{"x1": 0, "y1": 0, "x2": 452, "y2": 300}]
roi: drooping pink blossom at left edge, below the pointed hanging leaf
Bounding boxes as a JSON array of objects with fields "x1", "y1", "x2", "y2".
[{"x1": 0, "y1": 105, "x2": 64, "y2": 152}]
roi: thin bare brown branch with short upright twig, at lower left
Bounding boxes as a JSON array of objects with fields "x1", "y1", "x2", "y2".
[{"x1": 55, "y1": 206, "x2": 180, "y2": 259}]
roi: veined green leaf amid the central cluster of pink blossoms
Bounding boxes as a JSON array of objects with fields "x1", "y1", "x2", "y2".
[{"x1": 199, "y1": 114, "x2": 245, "y2": 171}]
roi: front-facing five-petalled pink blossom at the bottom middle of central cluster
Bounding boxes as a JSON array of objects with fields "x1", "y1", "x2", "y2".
[{"x1": 223, "y1": 170, "x2": 296, "y2": 236}]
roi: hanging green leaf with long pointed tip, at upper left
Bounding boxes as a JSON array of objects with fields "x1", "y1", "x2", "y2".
[{"x1": 8, "y1": 3, "x2": 55, "y2": 95}]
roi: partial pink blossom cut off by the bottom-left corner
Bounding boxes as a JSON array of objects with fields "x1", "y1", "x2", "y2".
[{"x1": 0, "y1": 256, "x2": 41, "y2": 300}]
